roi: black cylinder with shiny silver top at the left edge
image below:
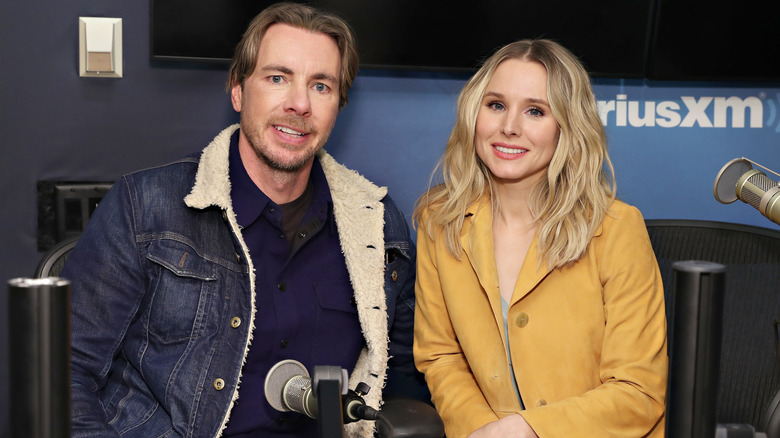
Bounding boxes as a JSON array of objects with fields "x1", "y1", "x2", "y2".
[{"x1": 8, "y1": 277, "x2": 70, "y2": 438}]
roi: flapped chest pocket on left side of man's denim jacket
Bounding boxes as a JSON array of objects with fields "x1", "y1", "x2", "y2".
[{"x1": 147, "y1": 240, "x2": 217, "y2": 343}]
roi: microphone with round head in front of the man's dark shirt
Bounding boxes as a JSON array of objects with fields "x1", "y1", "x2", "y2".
[{"x1": 264, "y1": 359, "x2": 378, "y2": 424}]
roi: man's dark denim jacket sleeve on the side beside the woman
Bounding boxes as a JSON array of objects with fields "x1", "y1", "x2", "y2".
[{"x1": 384, "y1": 197, "x2": 431, "y2": 403}]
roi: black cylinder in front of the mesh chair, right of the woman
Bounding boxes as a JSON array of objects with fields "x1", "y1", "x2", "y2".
[{"x1": 666, "y1": 261, "x2": 726, "y2": 438}]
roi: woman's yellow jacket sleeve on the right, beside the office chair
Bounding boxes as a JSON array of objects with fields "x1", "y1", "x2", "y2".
[{"x1": 521, "y1": 206, "x2": 668, "y2": 437}]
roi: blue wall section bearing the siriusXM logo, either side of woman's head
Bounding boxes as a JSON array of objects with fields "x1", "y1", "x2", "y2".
[{"x1": 329, "y1": 78, "x2": 780, "y2": 228}]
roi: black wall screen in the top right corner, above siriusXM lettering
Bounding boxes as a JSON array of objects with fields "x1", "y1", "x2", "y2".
[{"x1": 646, "y1": 0, "x2": 780, "y2": 81}]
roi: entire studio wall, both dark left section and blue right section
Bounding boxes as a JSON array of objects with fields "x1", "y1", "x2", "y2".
[{"x1": 0, "y1": 0, "x2": 780, "y2": 437}]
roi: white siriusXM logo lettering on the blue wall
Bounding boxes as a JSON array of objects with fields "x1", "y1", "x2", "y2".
[{"x1": 597, "y1": 94, "x2": 764, "y2": 128}]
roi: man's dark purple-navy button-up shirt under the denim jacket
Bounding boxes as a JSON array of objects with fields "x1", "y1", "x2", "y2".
[{"x1": 224, "y1": 131, "x2": 365, "y2": 438}]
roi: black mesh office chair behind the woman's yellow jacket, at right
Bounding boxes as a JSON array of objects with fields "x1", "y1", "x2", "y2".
[{"x1": 645, "y1": 219, "x2": 780, "y2": 437}]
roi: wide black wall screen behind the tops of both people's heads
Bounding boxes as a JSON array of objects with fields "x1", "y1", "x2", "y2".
[{"x1": 151, "y1": 0, "x2": 655, "y2": 78}]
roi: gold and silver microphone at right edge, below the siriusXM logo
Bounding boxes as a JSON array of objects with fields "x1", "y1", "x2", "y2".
[{"x1": 713, "y1": 157, "x2": 780, "y2": 224}]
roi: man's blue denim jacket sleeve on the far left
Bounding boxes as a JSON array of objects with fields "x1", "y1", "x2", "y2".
[{"x1": 61, "y1": 179, "x2": 144, "y2": 438}]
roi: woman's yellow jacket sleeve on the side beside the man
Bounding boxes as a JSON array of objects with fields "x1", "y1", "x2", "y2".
[{"x1": 414, "y1": 224, "x2": 498, "y2": 437}]
